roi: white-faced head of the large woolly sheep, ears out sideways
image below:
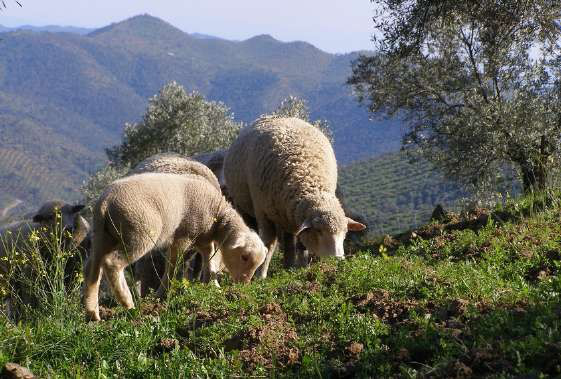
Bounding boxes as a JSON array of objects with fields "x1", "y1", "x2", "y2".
[{"x1": 295, "y1": 201, "x2": 366, "y2": 259}]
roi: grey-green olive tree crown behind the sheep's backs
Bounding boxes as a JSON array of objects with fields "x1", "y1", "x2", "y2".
[{"x1": 107, "y1": 82, "x2": 241, "y2": 166}]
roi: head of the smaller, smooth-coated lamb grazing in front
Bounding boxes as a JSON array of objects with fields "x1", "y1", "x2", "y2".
[{"x1": 221, "y1": 231, "x2": 267, "y2": 283}]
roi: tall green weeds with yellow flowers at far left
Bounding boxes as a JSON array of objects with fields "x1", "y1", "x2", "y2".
[{"x1": 0, "y1": 213, "x2": 83, "y2": 321}]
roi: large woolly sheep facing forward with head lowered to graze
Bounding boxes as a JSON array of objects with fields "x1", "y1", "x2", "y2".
[{"x1": 224, "y1": 117, "x2": 366, "y2": 278}]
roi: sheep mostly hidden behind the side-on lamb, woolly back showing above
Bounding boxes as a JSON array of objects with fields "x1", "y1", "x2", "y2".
[{"x1": 129, "y1": 153, "x2": 223, "y2": 296}]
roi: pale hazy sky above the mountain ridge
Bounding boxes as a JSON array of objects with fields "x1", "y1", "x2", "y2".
[{"x1": 0, "y1": 0, "x2": 374, "y2": 53}]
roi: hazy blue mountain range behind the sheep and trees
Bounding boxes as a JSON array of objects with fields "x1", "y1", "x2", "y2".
[{"x1": 0, "y1": 15, "x2": 401, "y2": 217}]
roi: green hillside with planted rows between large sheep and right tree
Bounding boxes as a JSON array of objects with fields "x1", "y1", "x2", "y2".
[{"x1": 339, "y1": 152, "x2": 470, "y2": 235}]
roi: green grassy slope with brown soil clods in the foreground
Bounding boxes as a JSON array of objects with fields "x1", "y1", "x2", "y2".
[{"x1": 0, "y1": 197, "x2": 561, "y2": 378}]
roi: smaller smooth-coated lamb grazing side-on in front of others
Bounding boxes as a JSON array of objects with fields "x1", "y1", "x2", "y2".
[{"x1": 84, "y1": 173, "x2": 267, "y2": 321}]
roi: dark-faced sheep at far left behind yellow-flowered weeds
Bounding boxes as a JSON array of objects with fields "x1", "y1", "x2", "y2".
[{"x1": 0, "y1": 200, "x2": 90, "y2": 318}]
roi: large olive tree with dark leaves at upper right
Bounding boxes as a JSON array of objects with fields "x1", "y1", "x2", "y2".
[{"x1": 349, "y1": 0, "x2": 561, "y2": 191}]
